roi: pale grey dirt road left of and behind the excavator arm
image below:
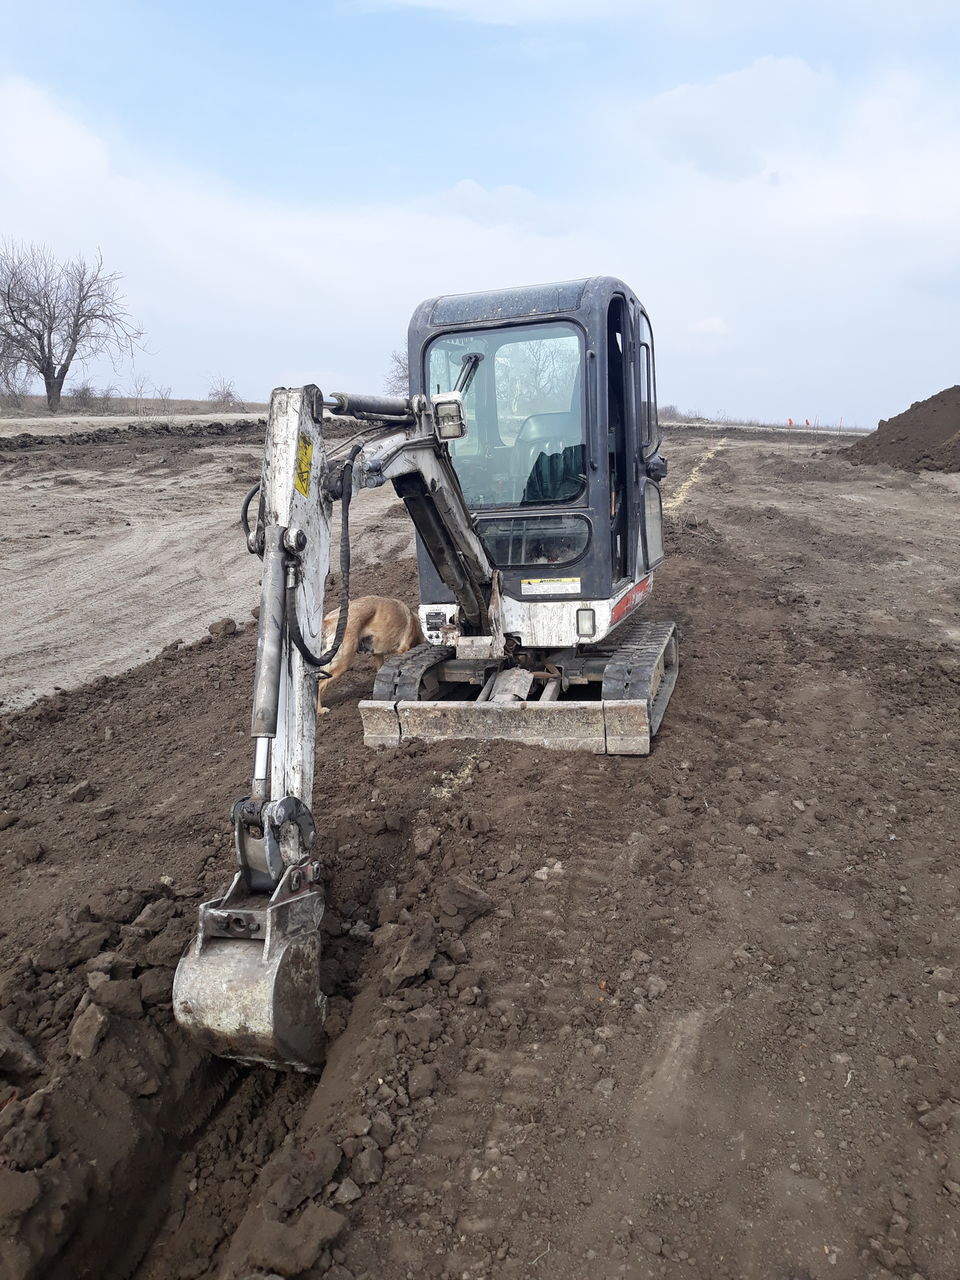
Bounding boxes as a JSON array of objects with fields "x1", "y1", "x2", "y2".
[{"x1": 0, "y1": 420, "x2": 412, "y2": 709}]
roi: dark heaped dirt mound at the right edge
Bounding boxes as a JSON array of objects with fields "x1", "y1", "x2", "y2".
[{"x1": 844, "y1": 387, "x2": 960, "y2": 471}]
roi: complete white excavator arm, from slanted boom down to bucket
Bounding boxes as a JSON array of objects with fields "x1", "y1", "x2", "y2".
[{"x1": 173, "y1": 387, "x2": 503, "y2": 1070}]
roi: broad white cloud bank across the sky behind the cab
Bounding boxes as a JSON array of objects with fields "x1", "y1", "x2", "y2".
[{"x1": 0, "y1": 66, "x2": 960, "y2": 424}]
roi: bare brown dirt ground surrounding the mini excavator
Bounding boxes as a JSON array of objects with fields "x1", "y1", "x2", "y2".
[{"x1": 0, "y1": 430, "x2": 960, "y2": 1280}]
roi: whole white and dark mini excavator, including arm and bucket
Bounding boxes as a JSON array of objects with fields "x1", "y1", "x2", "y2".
[{"x1": 174, "y1": 276, "x2": 677, "y2": 1071}]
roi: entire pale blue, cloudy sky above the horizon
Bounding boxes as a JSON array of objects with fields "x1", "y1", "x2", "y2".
[{"x1": 0, "y1": 0, "x2": 960, "y2": 426}]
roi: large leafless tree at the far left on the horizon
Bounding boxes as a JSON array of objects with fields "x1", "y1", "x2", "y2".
[{"x1": 0, "y1": 241, "x2": 143, "y2": 413}]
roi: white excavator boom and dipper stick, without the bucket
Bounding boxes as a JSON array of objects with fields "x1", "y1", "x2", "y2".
[{"x1": 234, "y1": 387, "x2": 502, "y2": 892}]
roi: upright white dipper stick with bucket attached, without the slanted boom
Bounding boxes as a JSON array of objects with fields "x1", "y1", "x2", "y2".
[{"x1": 173, "y1": 388, "x2": 332, "y2": 1070}]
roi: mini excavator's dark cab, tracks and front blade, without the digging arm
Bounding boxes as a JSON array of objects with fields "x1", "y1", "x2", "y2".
[{"x1": 361, "y1": 276, "x2": 677, "y2": 754}]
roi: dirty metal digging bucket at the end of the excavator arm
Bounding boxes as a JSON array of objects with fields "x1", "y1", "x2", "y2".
[{"x1": 173, "y1": 868, "x2": 326, "y2": 1071}]
